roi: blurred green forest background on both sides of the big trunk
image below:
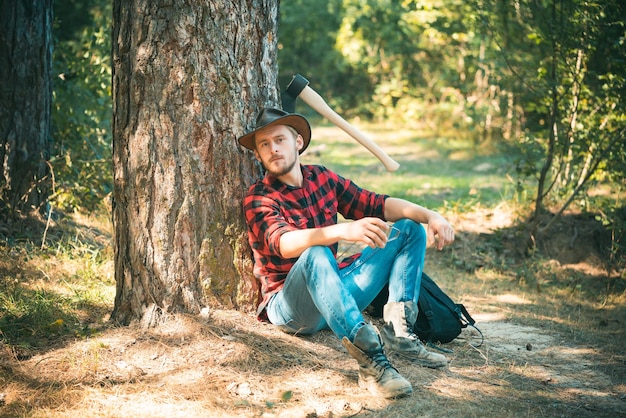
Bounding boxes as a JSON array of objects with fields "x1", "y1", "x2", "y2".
[{"x1": 18, "y1": 0, "x2": 626, "y2": 264}]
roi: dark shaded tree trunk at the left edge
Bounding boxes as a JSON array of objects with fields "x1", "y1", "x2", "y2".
[{"x1": 0, "y1": 0, "x2": 52, "y2": 220}]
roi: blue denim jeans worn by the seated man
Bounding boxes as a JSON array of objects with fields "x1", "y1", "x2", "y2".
[{"x1": 267, "y1": 219, "x2": 426, "y2": 341}]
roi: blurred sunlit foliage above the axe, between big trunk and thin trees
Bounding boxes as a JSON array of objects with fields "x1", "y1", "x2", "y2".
[{"x1": 279, "y1": 0, "x2": 519, "y2": 140}]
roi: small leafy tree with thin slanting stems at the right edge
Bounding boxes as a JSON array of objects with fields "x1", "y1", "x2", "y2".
[{"x1": 532, "y1": 0, "x2": 626, "y2": 233}]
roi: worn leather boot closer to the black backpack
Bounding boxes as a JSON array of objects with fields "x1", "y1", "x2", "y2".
[{"x1": 381, "y1": 301, "x2": 448, "y2": 368}]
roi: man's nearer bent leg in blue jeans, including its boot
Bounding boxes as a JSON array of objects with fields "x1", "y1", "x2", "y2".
[{"x1": 267, "y1": 246, "x2": 413, "y2": 398}]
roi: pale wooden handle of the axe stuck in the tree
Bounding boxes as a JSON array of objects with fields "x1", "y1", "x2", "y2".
[{"x1": 298, "y1": 86, "x2": 400, "y2": 171}]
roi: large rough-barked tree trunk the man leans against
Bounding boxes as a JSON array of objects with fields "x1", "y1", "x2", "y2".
[{"x1": 112, "y1": 0, "x2": 278, "y2": 325}]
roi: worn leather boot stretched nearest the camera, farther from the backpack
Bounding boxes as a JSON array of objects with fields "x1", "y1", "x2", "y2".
[{"x1": 341, "y1": 324, "x2": 413, "y2": 398}]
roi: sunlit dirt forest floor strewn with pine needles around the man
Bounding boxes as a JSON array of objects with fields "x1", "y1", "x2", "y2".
[{"x1": 0, "y1": 204, "x2": 626, "y2": 418}]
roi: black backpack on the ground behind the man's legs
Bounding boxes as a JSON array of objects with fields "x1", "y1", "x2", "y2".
[{"x1": 369, "y1": 273, "x2": 483, "y2": 347}]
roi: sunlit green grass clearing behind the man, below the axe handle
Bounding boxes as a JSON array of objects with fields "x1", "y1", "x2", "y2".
[{"x1": 303, "y1": 122, "x2": 530, "y2": 211}]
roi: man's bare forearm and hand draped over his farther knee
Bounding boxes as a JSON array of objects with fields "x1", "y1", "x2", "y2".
[{"x1": 385, "y1": 197, "x2": 454, "y2": 250}]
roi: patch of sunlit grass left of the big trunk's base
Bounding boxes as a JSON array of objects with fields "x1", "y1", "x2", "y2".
[{"x1": 0, "y1": 220, "x2": 114, "y2": 351}]
